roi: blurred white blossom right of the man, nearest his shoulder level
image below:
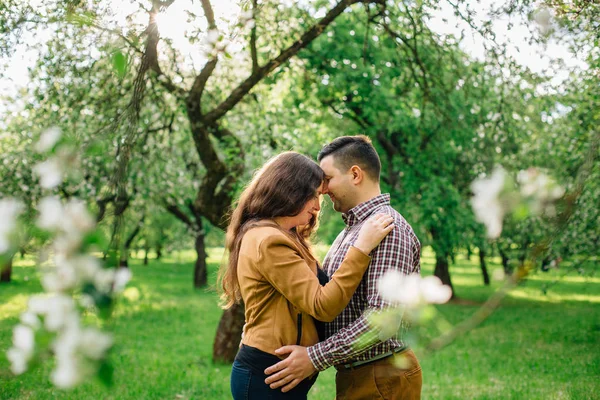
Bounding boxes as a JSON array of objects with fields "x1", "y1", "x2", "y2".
[{"x1": 471, "y1": 167, "x2": 506, "y2": 239}]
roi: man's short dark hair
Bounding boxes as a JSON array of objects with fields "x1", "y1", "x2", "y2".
[{"x1": 317, "y1": 135, "x2": 381, "y2": 182}]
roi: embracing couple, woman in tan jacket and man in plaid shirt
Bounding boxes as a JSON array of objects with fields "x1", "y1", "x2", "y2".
[{"x1": 222, "y1": 136, "x2": 422, "y2": 400}]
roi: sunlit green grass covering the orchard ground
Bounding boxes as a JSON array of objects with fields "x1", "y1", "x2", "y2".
[{"x1": 0, "y1": 250, "x2": 600, "y2": 400}]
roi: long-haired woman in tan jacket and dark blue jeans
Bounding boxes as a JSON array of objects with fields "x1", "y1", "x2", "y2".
[{"x1": 221, "y1": 152, "x2": 394, "y2": 400}]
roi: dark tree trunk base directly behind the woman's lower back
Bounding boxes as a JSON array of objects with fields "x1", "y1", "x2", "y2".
[{"x1": 213, "y1": 304, "x2": 245, "y2": 363}]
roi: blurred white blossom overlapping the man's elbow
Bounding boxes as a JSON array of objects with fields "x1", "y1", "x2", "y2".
[{"x1": 378, "y1": 271, "x2": 452, "y2": 307}]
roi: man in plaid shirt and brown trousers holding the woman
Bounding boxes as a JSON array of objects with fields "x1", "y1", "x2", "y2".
[{"x1": 265, "y1": 135, "x2": 422, "y2": 400}]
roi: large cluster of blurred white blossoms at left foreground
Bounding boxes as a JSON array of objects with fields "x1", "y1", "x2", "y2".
[{"x1": 6, "y1": 147, "x2": 122, "y2": 388}]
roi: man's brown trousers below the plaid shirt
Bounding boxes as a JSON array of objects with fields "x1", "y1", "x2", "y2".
[{"x1": 335, "y1": 349, "x2": 423, "y2": 400}]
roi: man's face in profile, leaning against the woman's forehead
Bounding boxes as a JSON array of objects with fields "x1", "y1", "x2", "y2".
[{"x1": 320, "y1": 156, "x2": 356, "y2": 213}]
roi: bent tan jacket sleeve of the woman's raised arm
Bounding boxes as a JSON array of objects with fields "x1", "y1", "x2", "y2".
[{"x1": 256, "y1": 235, "x2": 371, "y2": 322}]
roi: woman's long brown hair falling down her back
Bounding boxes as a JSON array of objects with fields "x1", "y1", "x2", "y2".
[{"x1": 219, "y1": 151, "x2": 325, "y2": 308}]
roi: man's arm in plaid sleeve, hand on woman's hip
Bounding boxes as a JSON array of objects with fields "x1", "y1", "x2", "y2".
[{"x1": 265, "y1": 223, "x2": 420, "y2": 392}]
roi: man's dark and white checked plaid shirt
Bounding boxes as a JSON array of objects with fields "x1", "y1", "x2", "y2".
[{"x1": 308, "y1": 194, "x2": 421, "y2": 371}]
